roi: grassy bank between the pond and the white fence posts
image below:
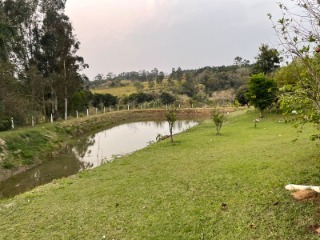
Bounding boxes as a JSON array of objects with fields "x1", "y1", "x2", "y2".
[{"x1": 0, "y1": 109, "x2": 218, "y2": 181}]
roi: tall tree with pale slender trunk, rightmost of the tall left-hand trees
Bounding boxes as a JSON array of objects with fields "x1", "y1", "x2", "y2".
[{"x1": 38, "y1": 0, "x2": 88, "y2": 118}]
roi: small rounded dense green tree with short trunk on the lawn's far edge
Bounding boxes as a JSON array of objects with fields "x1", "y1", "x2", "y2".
[{"x1": 246, "y1": 73, "x2": 277, "y2": 117}]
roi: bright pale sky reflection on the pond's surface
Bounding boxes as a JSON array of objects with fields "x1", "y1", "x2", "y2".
[{"x1": 73, "y1": 121, "x2": 197, "y2": 168}]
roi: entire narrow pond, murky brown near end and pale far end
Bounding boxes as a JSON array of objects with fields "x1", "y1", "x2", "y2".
[{"x1": 0, "y1": 120, "x2": 198, "y2": 199}]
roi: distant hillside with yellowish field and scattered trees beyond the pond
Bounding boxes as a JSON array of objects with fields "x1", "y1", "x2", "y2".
[{"x1": 89, "y1": 63, "x2": 251, "y2": 105}]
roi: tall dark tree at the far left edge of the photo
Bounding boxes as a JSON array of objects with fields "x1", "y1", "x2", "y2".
[{"x1": 0, "y1": 0, "x2": 39, "y2": 125}]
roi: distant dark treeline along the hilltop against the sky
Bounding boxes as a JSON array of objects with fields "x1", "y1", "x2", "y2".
[{"x1": 88, "y1": 57, "x2": 253, "y2": 97}]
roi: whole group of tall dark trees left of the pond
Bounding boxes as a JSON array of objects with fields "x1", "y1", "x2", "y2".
[{"x1": 0, "y1": 0, "x2": 88, "y2": 126}]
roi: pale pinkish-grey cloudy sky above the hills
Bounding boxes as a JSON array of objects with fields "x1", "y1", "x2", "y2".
[{"x1": 66, "y1": 0, "x2": 290, "y2": 79}]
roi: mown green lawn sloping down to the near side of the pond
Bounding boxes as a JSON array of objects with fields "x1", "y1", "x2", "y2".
[{"x1": 0, "y1": 110, "x2": 320, "y2": 240}]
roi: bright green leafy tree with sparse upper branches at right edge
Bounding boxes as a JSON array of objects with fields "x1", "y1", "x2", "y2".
[{"x1": 269, "y1": 0, "x2": 320, "y2": 139}]
